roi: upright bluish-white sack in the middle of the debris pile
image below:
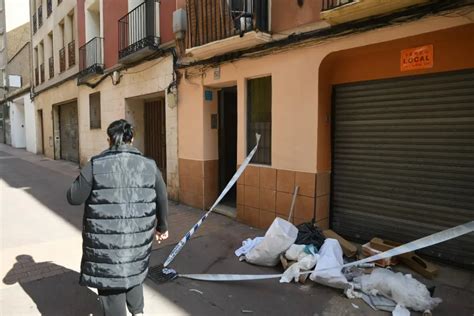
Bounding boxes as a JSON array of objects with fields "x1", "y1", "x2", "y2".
[{"x1": 309, "y1": 238, "x2": 348, "y2": 289}]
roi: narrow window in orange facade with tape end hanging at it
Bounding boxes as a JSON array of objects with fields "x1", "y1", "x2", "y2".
[{"x1": 247, "y1": 77, "x2": 272, "y2": 165}]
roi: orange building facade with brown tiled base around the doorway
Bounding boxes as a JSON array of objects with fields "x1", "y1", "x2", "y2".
[{"x1": 178, "y1": 1, "x2": 474, "y2": 248}]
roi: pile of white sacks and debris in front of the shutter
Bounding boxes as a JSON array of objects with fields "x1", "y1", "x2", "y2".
[{"x1": 235, "y1": 218, "x2": 441, "y2": 315}]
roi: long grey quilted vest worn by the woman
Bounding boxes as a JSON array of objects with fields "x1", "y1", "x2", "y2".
[{"x1": 80, "y1": 146, "x2": 157, "y2": 289}]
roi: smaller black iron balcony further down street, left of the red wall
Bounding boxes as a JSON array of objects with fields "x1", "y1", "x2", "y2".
[{"x1": 79, "y1": 37, "x2": 104, "y2": 80}]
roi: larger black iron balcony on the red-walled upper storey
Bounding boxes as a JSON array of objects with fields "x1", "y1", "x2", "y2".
[{"x1": 118, "y1": 0, "x2": 160, "y2": 64}]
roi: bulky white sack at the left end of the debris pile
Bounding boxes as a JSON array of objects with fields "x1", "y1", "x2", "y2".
[{"x1": 245, "y1": 217, "x2": 298, "y2": 267}]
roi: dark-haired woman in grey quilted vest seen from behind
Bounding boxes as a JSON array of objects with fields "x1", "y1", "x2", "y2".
[{"x1": 67, "y1": 120, "x2": 168, "y2": 316}]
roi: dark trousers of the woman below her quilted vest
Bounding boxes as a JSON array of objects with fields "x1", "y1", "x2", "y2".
[{"x1": 98, "y1": 284, "x2": 144, "y2": 316}]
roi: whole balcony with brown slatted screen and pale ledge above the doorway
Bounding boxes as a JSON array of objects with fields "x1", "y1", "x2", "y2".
[{"x1": 186, "y1": 0, "x2": 271, "y2": 59}]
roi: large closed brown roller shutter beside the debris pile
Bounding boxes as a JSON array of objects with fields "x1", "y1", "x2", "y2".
[{"x1": 331, "y1": 69, "x2": 474, "y2": 268}]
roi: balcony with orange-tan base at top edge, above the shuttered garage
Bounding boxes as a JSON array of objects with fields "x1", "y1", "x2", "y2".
[{"x1": 321, "y1": 0, "x2": 429, "y2": 25}]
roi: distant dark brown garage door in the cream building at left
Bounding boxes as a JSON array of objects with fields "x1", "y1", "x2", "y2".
[{"x1": 59, "y1": 102, "x2": 79, "y2": 162}]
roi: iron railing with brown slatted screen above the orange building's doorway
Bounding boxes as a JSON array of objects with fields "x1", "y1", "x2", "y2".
[{"x1": 186, "y1": 0, "x2": 269, "y2": 48}]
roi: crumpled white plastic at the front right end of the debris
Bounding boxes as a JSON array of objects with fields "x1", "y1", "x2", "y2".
[{"x1": 354, "y1": 268, "x2": 442, "y2": 312}]
